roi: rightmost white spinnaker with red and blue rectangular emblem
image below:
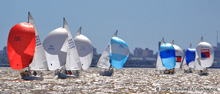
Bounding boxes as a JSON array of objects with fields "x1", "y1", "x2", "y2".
[{"x1": 196, "y1": 42, "x2": 214, "y2": 67}]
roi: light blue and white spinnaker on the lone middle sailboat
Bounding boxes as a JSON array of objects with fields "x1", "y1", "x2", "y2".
[{"x1": 110, "y1": 37, "x2": 130, "y2": 69}]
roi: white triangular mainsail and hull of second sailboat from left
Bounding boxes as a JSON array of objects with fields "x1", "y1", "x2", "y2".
[{"x1": 51, "y1": 18, "x2": 81, "y2": 79}]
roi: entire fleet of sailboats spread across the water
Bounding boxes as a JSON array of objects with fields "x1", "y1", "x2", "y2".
[{"x1": 7, "y1": 13, "x2": 214, "y2": 80}]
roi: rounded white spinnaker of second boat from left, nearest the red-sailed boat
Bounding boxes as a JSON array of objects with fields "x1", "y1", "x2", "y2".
[{"x1": 43, "y1": 27, "x2": 68, "y2": 70}]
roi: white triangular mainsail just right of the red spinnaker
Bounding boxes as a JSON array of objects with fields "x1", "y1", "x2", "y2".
[{"x1": 28, "y1": 12, "x2": 48, "y2": 70}]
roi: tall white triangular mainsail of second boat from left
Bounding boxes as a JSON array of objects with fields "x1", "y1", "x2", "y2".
[{"x1": 64, "y1": 18, "x2": 81, "y2": 70}]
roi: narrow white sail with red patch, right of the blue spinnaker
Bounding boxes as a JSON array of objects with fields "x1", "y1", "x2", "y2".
[{"x1": 172, "y1": 40, "x2": 184, "y2": 69}]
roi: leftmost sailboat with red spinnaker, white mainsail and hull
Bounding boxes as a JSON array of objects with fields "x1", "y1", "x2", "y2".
[{"x1": 7, "y1": 12, "x2": 43, "y2": 80}]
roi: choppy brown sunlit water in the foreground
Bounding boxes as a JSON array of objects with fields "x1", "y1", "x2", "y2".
[{"x1": 0, "y1": 67, "x2": 220, "y2": 94}]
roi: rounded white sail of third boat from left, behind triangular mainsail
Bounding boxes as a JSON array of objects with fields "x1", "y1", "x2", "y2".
[{"x1": 74, "y1": 27, "x2": 93, "y2": 70}]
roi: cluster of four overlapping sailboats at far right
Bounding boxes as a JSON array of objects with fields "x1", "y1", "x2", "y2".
[{"x1": 156, "y1": 37, "x2": 214, "y2": 75}]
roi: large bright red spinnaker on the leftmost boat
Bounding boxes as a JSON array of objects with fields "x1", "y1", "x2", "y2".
[{"x1": 7, "y1": 22, "x2": 36, "y2": 70}]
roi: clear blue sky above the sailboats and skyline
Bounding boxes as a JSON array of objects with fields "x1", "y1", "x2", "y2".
[{"x1": 0, "y1": 0, "x2": 220, "y2": 53}]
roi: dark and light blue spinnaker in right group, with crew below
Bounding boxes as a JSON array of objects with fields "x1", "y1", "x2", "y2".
[{"x1": 159, "y1": 38, "x2": 176, "y2": 74}]
